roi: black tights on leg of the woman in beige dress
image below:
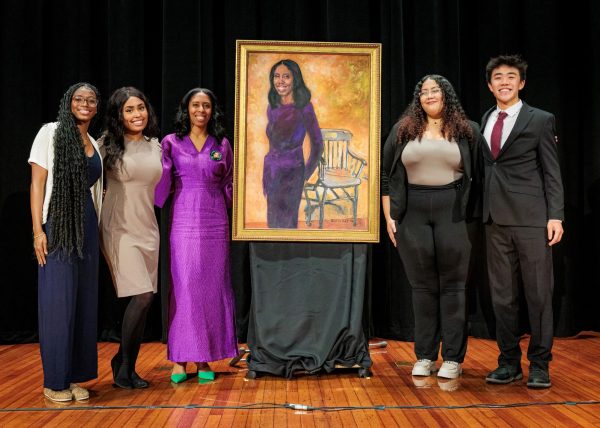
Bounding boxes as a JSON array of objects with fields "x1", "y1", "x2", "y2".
[{"x1": 115, "y1": 292, "x2": 154, "y2": 380}]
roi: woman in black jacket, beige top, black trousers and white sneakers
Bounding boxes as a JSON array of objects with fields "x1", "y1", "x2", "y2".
[{"x1": 382, "y1": 74, "x2": 482, "y2": 379}]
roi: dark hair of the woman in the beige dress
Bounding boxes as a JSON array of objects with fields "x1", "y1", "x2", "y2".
[{"x1": 102, "y1": 86, "x2": 160, "y2": 170}]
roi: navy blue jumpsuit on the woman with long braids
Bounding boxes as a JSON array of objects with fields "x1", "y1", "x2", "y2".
[{"x1": 38, "y1": 150, "x2": 102, "y2": 390}]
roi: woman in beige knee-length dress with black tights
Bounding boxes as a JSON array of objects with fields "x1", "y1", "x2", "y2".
[{"x1": 100, "y1": 87, "x2": 162, "y2": 389}]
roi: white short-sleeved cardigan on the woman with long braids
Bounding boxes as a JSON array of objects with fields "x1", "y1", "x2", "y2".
[{"x1": 28, "y1": 122, "x2": 103, "y2": 224}]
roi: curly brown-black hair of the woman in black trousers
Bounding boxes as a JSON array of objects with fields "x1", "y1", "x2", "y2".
[{"x1": 398, "y1": 74, "x2": 473, "y2": 143}]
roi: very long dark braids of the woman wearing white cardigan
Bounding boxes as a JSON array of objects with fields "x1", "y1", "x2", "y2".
[{"x1": 48, "y1": 82, "x2": 100, "y2": 258}]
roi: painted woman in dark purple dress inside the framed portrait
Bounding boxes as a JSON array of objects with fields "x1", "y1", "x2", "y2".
[{"x1": 263, "y1": 59, "x2": 323, "y2": 229}]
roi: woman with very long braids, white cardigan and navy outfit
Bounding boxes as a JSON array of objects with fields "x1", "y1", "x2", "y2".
[{"x1": 29, "y1": 83, "x2": 102, "y2": 401}]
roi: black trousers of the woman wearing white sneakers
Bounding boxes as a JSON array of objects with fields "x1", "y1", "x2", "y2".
[{"x1": 396, "y1": 183, "x2": 471, "y2": 363}]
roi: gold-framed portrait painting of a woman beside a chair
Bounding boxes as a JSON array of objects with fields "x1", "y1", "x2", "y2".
[{"x1": 232, "y1": 40, "x2": 381, "y2": 242}]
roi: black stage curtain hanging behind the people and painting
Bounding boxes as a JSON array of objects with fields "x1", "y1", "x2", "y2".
[{"x1": 0, "y1": 0, "x2": 600, "y2": 343}]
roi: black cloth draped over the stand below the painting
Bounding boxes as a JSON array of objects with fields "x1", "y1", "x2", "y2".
[{"x1": 248, "y1": 243, "x2": 371, "y2": 378}]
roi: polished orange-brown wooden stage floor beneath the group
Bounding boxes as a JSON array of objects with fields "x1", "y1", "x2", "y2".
[{"x1": 0, "y1": 332, "x2": 600, "y2": 427}]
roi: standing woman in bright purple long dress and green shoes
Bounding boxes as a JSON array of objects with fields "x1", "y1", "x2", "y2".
[{"x1": 155, "y1": 88, "x2": 237, "y2": 383}]
